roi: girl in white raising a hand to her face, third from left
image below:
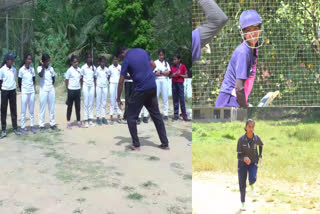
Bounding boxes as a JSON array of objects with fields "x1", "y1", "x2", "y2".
[{"x1": 37, "y1": 54, "x2": 57, "y2": 132}]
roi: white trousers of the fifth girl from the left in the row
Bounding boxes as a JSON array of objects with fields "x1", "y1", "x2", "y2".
[{"x1": 82, "y1": 85, "x2": 94, "y2": 120}]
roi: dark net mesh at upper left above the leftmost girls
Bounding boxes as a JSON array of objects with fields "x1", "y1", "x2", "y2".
[{"x1": 0, "y1": 0, "x2": 34, "y2": 68}]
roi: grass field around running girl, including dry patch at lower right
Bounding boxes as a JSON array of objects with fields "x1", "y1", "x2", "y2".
[{"x1": 192, "y1": 120, "x2": 320, "y2": 213}]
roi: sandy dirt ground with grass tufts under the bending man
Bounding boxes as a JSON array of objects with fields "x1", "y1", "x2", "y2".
[{"x1": 0, "y1": 97, "x2": 192, "y2": 214}]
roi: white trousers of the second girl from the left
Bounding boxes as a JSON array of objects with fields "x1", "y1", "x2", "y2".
[{"x1": 21, "y1": 92, "x2": 35, "y2": 129}]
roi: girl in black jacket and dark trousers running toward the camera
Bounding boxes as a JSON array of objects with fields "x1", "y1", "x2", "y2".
[{"x1": 237, "y1": 119, "x2": 263, "y2": 210}]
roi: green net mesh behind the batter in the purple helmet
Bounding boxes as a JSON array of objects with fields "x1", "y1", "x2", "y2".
[{"x1": 192, "y1": 0, "x2": 320, "y2": 107}]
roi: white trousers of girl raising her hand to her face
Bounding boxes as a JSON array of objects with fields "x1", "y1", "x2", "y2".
[{"x1": 39, "y1": 88, "x2": 56, "y2": 127}]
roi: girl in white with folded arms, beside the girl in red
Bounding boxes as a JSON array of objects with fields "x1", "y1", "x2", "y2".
[{"x1": 154, "y1": 49, "x2": 171, "y2": 120}]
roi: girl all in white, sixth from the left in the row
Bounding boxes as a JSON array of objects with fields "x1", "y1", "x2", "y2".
[{"x1": 95, "y1": 56, "x2": 109, "y2": 126}]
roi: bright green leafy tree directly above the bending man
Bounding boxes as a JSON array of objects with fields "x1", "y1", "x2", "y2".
[{"x1": 104, "y1": 0, "x2": 154, "y2": 51}]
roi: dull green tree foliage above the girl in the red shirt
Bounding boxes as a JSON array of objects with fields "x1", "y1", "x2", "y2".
[{"x1": 152, "y1": 0, "x2": 192, "y2": 68}]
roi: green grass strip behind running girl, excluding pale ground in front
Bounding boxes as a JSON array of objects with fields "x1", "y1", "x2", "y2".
[{"x1": 192, "y1": 120, "x2": 320, "y2": 183}]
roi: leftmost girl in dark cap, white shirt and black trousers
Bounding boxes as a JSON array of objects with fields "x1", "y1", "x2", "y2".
[{"x1": 0, "y1": 53, "x2": 20, "y2": 138}]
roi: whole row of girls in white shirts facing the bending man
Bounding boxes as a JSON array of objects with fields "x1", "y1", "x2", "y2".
[{"x1": 0, "y1": 49, "x2": 190, "y2": 137}]
